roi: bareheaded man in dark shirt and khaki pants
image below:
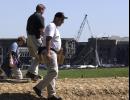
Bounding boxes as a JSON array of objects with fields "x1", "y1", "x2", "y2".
[{"x1": 26, "y1": 4, "x2": 45, "y2": 81}]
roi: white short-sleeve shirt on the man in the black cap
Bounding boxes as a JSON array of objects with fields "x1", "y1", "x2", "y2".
[{"x1": 43, "y1": 23, "x2": 61, "y2": 51}]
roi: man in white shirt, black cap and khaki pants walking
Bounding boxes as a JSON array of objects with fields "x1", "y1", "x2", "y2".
[{"x1": 33, "y1": 12, "x2": 67, "y2": 100}]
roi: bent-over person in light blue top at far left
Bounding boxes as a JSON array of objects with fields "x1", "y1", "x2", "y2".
[{"x1": 1, "y1": 36, "x2": 26, "y2": 79}]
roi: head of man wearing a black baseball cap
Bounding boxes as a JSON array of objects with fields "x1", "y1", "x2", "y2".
[{"x1": 54, "y1": 12, "x2": 68, "y2": 26}]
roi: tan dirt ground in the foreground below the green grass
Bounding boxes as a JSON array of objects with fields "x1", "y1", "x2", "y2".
[{"x1": 0, "y1": 77, "x2": 129, "y2": 100}]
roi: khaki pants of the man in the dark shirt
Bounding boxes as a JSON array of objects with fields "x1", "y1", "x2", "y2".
[{"x1": 27, "y1": 35, "x2": 42, "y2": 75}]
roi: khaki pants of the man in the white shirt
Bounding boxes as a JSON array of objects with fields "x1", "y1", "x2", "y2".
[{"x1": 36, "y1": 51, "x2": 58, "y2": 97}]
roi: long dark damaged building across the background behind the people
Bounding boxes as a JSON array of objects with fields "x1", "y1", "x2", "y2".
[{"x1": 0, "y1": 37, "x2": 129, "y2": 66}]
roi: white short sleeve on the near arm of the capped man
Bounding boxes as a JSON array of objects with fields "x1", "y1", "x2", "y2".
[{"x1": 45, "y1": 24, "x2": 56, "y2": 37}]
